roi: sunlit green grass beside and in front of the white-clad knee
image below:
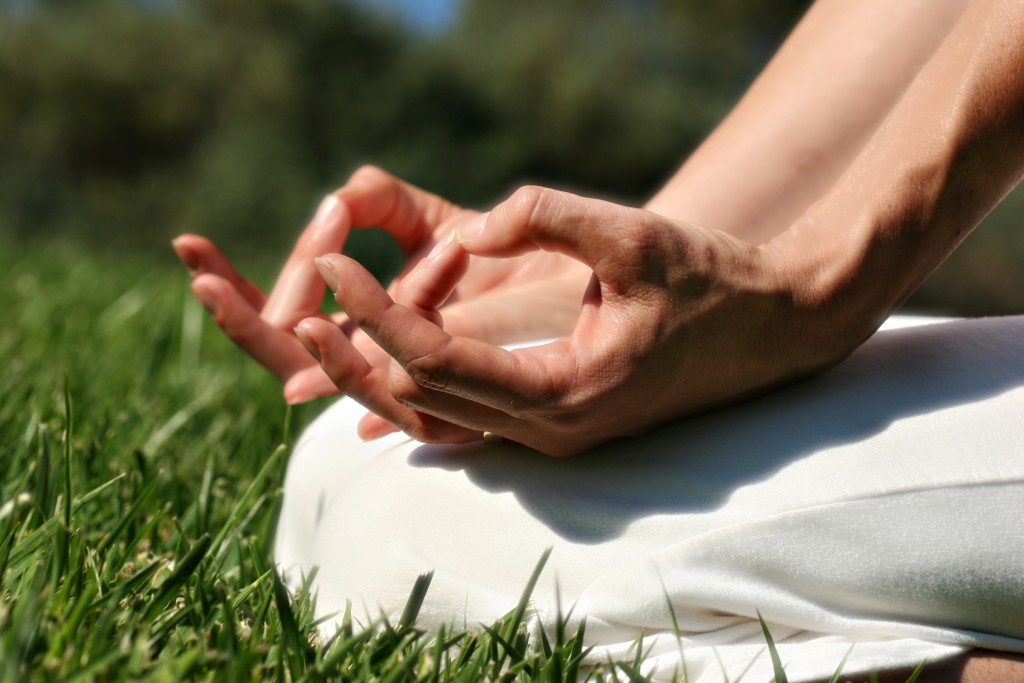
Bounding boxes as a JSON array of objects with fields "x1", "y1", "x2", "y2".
[{"x1": 0, "y1": 239, "x2": 933, "y2": 682}]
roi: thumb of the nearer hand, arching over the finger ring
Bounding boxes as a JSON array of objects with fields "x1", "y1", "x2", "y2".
[{"x1": 458, "y1": 187, "x2": 667, "y2": 289}]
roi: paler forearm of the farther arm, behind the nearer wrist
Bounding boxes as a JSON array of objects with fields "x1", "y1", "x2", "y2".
[{"x1": 646, "y1": 0, "x2": 965, "y2": 244}]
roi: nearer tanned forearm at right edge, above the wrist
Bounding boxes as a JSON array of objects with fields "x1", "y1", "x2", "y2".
[{"x1": 765, "y1": 0, "x2": 1024, "y2": 339}]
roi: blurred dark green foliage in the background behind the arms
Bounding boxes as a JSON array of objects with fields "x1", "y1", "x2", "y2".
[{"x1": 0, "y1": 0, "x2": 1024, "y2": 312}]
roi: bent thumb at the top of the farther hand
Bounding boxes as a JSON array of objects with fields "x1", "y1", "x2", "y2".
[{"x1": 335, "y1": 166, "x2": 462, "y2": 254}]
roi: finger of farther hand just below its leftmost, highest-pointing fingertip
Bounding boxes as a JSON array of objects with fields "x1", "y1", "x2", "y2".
[{"x1": 191, "y1": 273, "x2": 315, "y2": 381}]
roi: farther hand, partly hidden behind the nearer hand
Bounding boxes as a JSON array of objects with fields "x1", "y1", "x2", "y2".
[{"x1": 174, "y1": 167, "x2": 589, "y2": 409}]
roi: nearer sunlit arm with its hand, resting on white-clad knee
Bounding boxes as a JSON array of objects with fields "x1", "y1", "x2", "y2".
[{"x1": 302, "y1": 0, "x2": 1024, "y2": 455}]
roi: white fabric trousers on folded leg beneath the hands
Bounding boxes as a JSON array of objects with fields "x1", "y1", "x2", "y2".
[{"x1": 276, "y1": 317, "x2": 1024, "y2": 683}]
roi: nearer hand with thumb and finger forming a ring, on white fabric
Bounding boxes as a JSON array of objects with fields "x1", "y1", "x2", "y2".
[{"x1": 300, "y1": 188, "x2": 869, "y2": 456}]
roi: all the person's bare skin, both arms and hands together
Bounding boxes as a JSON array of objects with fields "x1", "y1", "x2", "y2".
[{"x1": 175, "y1": 0, "x2": 1024, "y2": 681}]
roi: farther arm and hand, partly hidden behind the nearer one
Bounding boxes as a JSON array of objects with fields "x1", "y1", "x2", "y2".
[{"x1": 175, "y1": 0, "x2": 983, "y2": 437}]
